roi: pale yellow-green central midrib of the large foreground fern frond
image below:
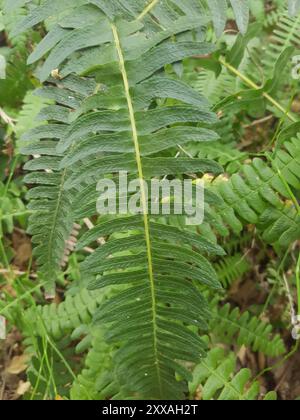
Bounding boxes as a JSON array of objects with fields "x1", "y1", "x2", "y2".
[{"x1": 111, "y1": 24, "x2": 162, "y2": 394}]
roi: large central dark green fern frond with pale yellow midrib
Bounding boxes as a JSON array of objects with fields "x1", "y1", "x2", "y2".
[{"x1": 16, "y1": 1, "x2": 227, "y2": 398}]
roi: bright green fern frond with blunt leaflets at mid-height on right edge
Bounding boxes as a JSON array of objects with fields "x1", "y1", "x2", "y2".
[{"x1": 203, "y1": 137, "x2": 300, "y2": 246}]
